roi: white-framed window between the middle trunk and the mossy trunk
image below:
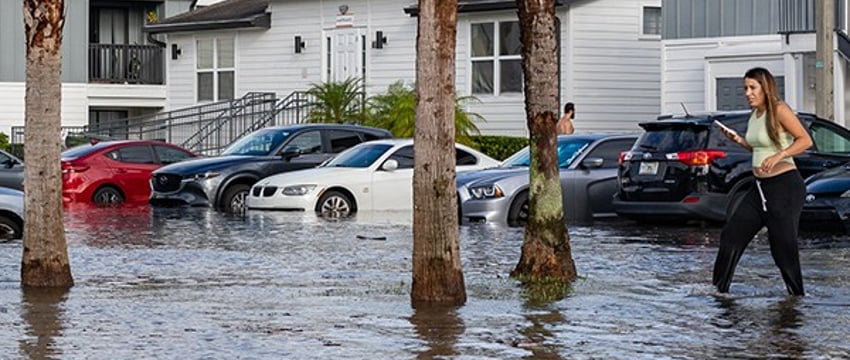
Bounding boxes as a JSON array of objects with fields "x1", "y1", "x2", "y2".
[{"x1": 469, "y1": 21, "x2": 522, "y2": 96}]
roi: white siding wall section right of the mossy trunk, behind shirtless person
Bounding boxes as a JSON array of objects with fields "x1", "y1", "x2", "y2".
[{"x1": 562, "y1": 0, "x2": 661, "y2": 131}]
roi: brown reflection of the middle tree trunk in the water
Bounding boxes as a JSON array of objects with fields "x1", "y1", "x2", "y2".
[{"x1": 410, "y1": 306, "x2": 465, "y2": 359}]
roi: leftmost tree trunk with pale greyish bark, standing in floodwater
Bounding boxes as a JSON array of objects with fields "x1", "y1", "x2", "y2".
[{"x1": 21, "y1": 0, "x2": 74, "y2": 287}]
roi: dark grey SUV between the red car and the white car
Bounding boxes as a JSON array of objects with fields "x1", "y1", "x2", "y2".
[{"x1": 150, "y1": 124, "x2": 392, "y2": 212}]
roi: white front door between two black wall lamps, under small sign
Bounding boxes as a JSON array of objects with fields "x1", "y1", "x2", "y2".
[{"x1": 324, "y1": 28, "x2": 366, "y2": 82}]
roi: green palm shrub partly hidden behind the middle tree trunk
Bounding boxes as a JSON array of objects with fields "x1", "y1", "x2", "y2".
[{"x1": 366, "y1": 81, "x2": 484, "y2": 146}]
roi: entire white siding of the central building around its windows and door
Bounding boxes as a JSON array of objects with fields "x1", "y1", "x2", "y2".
[{"x1": 162, "y1": 0, "x2": 660, "y2": 135}]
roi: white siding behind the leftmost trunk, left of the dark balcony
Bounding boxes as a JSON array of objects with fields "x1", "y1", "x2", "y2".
[{"x1": 0, "y1": 82, "x2": 89, "y2": 135}]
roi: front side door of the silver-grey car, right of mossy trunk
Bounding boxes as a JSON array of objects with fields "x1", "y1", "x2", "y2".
[{"x1": 561, "y1": 137, "x2": 637, "y2": 220}]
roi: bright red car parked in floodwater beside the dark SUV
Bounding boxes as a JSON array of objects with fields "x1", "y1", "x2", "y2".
[{"x1": 62, "y1": 140, "x2": 197, "y2": 205}]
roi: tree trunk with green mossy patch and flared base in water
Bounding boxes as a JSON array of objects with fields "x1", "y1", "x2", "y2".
[{"x1": 511, "y1": 0, "x2": 576, "y2": 282}]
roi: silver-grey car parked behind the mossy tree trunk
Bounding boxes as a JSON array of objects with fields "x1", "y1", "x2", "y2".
[{"x1": 457, "y1": 134, "x2": 637, "y2": 226}]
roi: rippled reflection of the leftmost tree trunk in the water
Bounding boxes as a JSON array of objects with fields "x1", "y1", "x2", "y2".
[{"x1": 19, "y1": 287, "x2": 68, "y2": 360}]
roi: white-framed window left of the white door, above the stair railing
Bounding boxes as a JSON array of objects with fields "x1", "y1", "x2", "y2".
[{"x1": 196, "y1": 37, "x2": 236, "y2": 102}]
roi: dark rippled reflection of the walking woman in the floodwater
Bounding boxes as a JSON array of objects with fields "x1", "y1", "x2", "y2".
[{"x1": 713, "y1": 296, "x2": 808, "y2": 359}]
